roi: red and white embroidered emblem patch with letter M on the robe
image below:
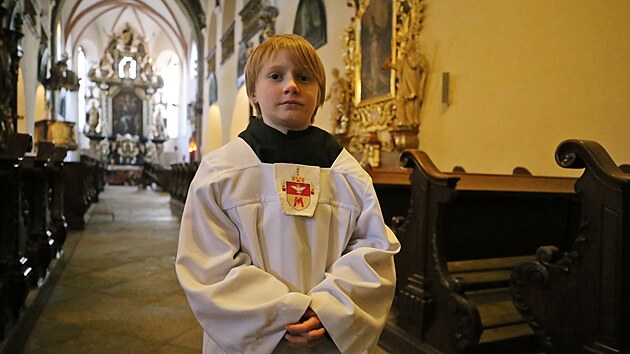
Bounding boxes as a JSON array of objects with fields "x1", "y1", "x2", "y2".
[{"x1": 274, "y1": 164, "x2": 320, "y2": 217}]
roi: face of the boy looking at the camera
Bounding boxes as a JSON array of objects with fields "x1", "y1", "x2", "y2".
[{"x1": 252, "y1": 50, "x2": 319, "y2": 133}]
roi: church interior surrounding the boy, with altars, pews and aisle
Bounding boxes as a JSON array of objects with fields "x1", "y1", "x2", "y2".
[{"x1": 0, "y1": 0, "x2": 630, "y2": 354}]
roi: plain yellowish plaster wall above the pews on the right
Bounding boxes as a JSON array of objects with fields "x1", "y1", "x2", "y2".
[{"x1": 420, "y1": 0, "x2": 630, "y2": 175}]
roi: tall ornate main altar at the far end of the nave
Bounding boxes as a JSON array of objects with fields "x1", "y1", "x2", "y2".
[{"x1": 83, "y1": 24, "x2": 168, "y2": 165}]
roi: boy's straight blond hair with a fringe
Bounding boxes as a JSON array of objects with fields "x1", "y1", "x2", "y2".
[{"x1": 245, "y1": 34, "x2": 326, "y2": 122}]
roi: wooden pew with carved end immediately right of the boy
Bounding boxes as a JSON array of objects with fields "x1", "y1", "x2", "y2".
[{"x1": 380, "y1": 150, "x2": 580, "y2": 354}]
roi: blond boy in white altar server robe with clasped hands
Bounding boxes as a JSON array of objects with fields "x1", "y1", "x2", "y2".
[{"x1": 176, "y1": 35, "x2": 400, "y2": 354}]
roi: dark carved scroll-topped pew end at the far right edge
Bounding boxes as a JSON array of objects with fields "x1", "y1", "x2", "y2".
[{"x1": 511, "y1": 140, "x2": 630, "y2": 353}]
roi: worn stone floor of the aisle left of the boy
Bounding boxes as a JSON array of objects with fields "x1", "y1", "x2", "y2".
[{"x1": 23, "y1": 186, "x2": 386, "y2": 354}]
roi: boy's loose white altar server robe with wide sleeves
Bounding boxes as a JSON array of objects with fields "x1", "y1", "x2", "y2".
[{"x1": 176, "y1": 138, "x2": 400, "y2": 354}]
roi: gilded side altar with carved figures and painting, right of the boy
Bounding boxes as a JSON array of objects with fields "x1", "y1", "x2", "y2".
[{"x1": 330, "y1": 0, "x2": 429, "y2": 167}]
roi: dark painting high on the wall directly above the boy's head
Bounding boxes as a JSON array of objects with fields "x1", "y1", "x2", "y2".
[{"x1": 293, "y1": 0, "x2": 327, "y2": 48}]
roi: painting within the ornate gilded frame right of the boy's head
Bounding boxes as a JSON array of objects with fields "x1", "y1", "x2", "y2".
[{"x1": 355, "y1": 0, "x2": 396, "y2": 106}]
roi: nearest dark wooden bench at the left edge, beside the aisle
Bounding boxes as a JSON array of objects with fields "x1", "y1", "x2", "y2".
[{"x1": 0, "y1": 133, "x2": 71, "y2": 353}]
